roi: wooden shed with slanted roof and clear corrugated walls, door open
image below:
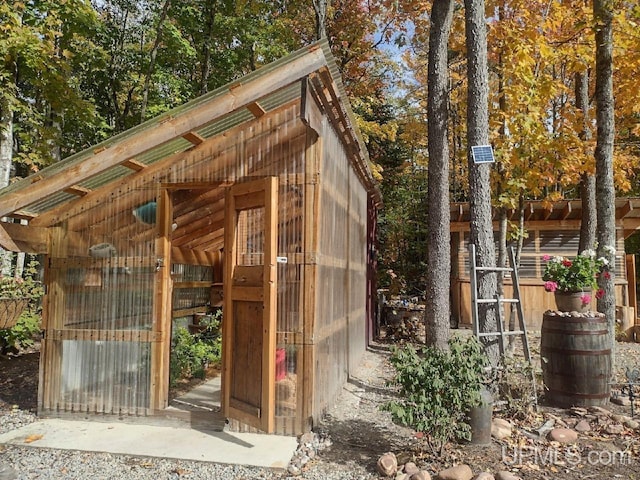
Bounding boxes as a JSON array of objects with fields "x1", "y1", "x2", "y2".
[{"x1": 0, "y1": 42, "x2": 379, "y2": 434}]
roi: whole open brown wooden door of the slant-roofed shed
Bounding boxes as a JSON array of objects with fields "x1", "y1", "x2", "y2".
[{"x1": 222, "y1": 177, "x2": 278, "y2": 433}]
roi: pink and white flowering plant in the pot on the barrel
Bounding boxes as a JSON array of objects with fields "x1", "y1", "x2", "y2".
[{"x1": 542, "y1": 249, "x2": 615, "y2": 304}]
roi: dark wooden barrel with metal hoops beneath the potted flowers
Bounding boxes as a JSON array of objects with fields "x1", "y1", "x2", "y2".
[{"x1": 540, "y1": 311, "x2": 612, "y2": 407}]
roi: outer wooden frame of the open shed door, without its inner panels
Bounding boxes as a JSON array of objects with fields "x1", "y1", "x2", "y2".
[{"x1": 222, "y1": 177, "x2": 278, "y2": 433}]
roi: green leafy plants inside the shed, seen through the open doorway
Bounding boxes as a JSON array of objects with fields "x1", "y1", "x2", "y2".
[{"x1": 169, "y1": 311, "x2": 222, "y2": 387}]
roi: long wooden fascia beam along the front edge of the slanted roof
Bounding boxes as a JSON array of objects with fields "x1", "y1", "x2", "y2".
[{"x1": 0, "y1": 48, "x2": 326, "y2": 217}]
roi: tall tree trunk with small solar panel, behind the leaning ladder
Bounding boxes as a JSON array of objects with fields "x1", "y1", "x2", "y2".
[{"x1": 464, "y1": 0, "x2": 500, "y2": 366}]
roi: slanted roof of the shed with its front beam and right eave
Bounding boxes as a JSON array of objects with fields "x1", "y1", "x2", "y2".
[{"x1": 0, "y1": 40, "x2": 375, "y2": 218}]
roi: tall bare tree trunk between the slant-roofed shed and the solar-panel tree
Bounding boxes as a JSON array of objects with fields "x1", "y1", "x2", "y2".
[{"x1": 425, "y1": 0, "x2": 453, "y2": 349}]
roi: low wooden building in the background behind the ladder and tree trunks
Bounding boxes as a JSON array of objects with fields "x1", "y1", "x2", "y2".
[{"x1": 451, "y1": 198, "x2": 640, "y2": 328}]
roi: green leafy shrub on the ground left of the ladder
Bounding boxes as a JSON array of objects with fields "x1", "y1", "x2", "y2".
[{"x1": 383, "y1": 336, "x2": 487, "y2": 455}]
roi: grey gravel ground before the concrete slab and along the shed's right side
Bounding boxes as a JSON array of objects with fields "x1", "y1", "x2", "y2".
[{"x1": 0, "y1": 346, "x2": 410, "y2": 480}]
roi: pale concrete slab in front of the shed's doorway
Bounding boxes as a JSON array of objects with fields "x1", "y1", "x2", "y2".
[{"x1": 0, "y1": 419, "x2": 297, "y2": 468}]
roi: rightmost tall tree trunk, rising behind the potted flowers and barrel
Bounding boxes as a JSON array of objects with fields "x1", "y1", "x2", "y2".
[{"x1": 593, "y1": 0, "x2": 616, "y2": 371}]
